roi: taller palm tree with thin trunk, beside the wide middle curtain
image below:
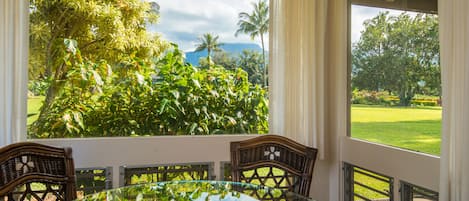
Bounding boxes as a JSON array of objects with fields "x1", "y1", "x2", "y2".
[{"x1": 235, "y1": 0, "x2": 269, "y2": 87}]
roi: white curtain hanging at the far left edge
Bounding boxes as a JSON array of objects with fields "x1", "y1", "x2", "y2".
[{"x1": 0, "y1": 0, "x2": 29, "y2": 147}]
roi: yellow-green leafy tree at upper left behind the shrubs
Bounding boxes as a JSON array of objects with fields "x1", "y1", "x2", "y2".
[{"x1": 29, "y1": 0, "x2": 169, "y2": 127}]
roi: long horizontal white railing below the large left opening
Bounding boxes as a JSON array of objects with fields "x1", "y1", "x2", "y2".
[{"x1": 32, "y1": 135, "x2": 257, "y2": 188}]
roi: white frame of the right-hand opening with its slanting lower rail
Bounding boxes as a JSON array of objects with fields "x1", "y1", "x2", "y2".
[{"x1": 341, "y1": 0, "x2": 440, "y2": 201}]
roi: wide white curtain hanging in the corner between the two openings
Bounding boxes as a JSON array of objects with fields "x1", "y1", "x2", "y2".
[{"x1": 269, "y1": 0, "x2": 346, "y2": 159}]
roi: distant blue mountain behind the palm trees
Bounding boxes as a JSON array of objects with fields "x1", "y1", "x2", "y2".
[{"x1": 186, "y1": 43, "x2": 262, "y2": 66}]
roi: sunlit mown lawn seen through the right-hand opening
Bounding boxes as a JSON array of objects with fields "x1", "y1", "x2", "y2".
[{"x1": 351, "y1": 105, "x2": 441, "y2": 155}]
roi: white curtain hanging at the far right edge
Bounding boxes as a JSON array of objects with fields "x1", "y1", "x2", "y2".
[{"x1": 438, "y1": 0, "x2": 469, "y2": 201}]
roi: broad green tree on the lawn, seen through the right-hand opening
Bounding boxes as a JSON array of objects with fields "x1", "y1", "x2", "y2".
[{"x1": 352, "y1": 12, "x2": 441, "y2": 106}]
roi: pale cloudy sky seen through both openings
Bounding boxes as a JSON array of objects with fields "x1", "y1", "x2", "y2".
[{"x1": 150, "y1": 0, "x2": 414, "y2": 51}]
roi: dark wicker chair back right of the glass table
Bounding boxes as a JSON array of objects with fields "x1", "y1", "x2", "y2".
[{"x1": 230, "y1": 135, "x2": 317, "y2": 200}]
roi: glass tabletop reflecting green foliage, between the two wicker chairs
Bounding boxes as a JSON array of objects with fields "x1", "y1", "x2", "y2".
[{"x1": 78, "y1": 181, "x2": 314, "y2": 201}]
